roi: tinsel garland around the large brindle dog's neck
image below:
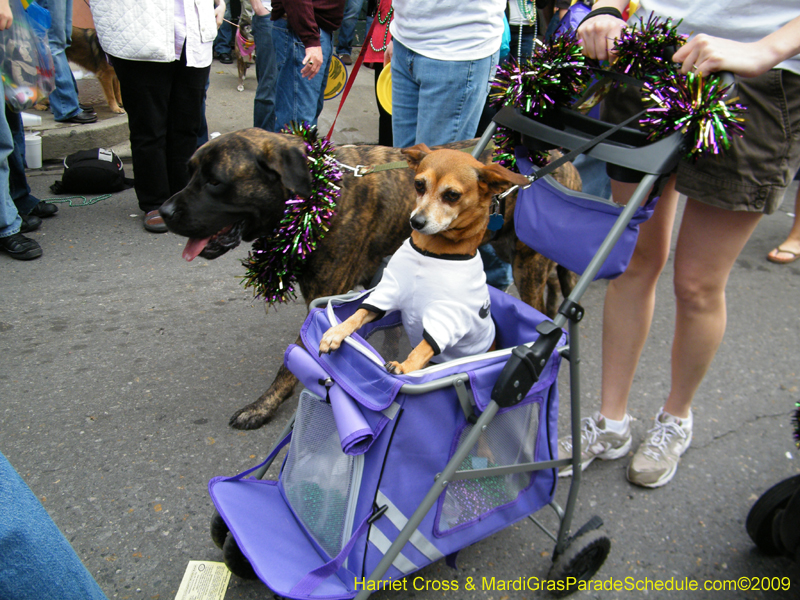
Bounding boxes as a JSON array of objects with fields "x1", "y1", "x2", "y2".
[{"x1": 242, "y1": 123, "x2": 342, "y2": 306}]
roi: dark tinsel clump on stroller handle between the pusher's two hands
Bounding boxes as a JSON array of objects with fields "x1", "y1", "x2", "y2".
[{"x1": 612, "y1": 13, "x2": 686, "y2": 80}]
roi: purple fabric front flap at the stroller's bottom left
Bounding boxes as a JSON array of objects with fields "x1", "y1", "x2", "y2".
[{"x1": 208, "y1": 477, "x2": 354, "y2": 599}]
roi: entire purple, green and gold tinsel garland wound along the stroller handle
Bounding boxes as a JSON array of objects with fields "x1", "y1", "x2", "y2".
[{"x1": 489, "y1": 14, "x2": 745, "y2": 168}]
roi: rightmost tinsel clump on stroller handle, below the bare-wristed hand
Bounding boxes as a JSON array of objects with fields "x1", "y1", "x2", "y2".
[{"x1": 641, "y1": 73, "x2": 745, "y2": 160}]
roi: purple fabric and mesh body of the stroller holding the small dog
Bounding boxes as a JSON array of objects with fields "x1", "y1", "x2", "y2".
[{"x1": 209, "y1": 288, "x2": 566, "y2": 599}]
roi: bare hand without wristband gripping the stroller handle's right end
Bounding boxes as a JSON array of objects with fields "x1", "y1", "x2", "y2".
[{"x1": 672, "y1": 33, "x2": 774, "y2": 77}]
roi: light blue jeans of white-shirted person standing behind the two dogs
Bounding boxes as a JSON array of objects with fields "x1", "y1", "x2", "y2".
[{"x1": 391, "y1": 40, "x2": 499, "y2": 148}]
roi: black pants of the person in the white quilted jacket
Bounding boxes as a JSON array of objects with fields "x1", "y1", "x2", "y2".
[{"x1": 111, "y1": 49, "x2": 210, "y2": 212}]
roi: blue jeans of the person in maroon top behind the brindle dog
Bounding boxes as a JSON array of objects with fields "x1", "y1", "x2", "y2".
[{"x1": 272, "y1": 19, "x2": 333, "y2": 131}]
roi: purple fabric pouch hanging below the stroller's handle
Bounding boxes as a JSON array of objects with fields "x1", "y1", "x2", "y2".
[{"x1": 514, "y1": 148, "x2": 655, "y2": 279}]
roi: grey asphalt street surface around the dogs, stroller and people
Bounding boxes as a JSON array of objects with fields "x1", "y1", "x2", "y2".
[{"x1": 0, "y1": 61, "x2": 800, "y2": 600}]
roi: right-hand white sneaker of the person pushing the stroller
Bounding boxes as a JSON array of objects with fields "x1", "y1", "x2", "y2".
[{"x1": 628, "y1": 409, "x2": 692, "y2": 488}]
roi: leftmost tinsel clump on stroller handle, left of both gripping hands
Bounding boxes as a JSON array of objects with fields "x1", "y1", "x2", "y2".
[{"x1": 489, "y1": 31, "x2": 591, "y2": 118}]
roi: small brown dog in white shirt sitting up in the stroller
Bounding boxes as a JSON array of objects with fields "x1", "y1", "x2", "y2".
[{"x1": 319, "y1": 144, "x2": 528, "y2": 375}]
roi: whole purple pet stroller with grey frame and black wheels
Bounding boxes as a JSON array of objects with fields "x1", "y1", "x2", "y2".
[{"x1": 209, "y1": 95, "x2": 682, "y2": 600}]
